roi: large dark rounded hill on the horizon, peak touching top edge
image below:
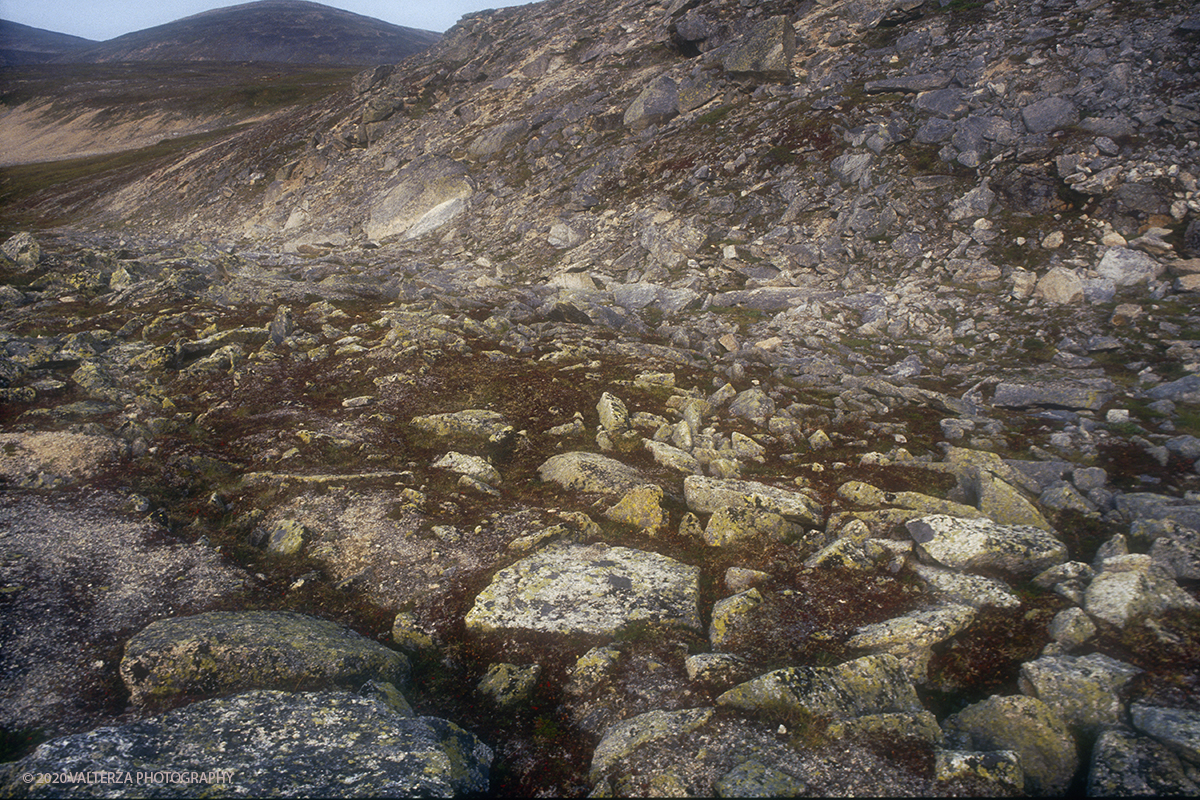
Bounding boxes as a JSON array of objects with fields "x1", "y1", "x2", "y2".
[{"x1": 52, "y1": 0, "x2": 442, "y2": 66}]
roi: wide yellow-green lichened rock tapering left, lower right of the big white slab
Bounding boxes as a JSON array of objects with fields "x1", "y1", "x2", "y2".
[{"x1": 716, "y1": 655, "x2": 922, "y2": 720}]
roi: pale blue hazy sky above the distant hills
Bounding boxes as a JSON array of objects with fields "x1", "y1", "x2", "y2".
[{"x1": 0, "y1": 0, "x2": 523, "y2": 41}]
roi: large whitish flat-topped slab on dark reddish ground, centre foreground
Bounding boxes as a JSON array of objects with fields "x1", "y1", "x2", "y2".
[{"x1": 467, "y1": 543, "x2": 700, "y2": 636}]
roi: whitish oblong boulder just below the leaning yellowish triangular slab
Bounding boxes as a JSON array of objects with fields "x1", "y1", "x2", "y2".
[{"x1": 906, "y1": 516, "x2": 1067, "y2": 577}]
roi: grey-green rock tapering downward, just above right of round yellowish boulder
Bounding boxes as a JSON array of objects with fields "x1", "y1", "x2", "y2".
[{"x1": 1020, "y1": 652, "x2": 1141, "y2": 736}]
